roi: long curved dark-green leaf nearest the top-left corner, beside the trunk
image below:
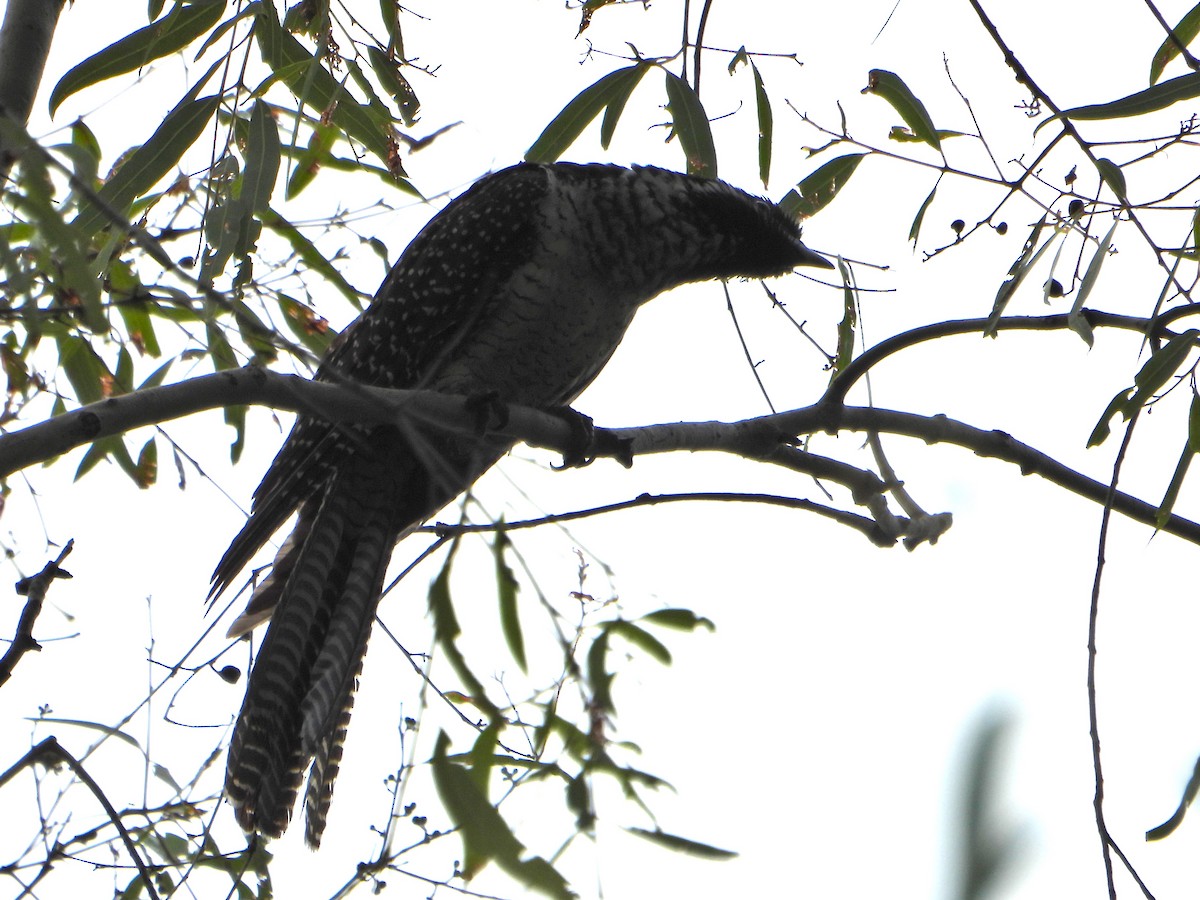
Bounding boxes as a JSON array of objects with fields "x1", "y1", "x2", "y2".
[{"x1": 49, "y1": 0, "x2": 226, "y2": 115}]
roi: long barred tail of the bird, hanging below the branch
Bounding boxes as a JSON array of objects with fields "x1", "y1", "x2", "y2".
[{"x1": 226, "y1": 464, "x2": 397, "y2": 847}]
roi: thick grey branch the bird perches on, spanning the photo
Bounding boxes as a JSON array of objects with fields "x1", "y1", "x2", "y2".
[{"x1": 0, "y1": 367, "x2": 1200, "y2": 544}]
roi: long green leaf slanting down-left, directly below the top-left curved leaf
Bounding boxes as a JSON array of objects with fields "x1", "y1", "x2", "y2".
[{"x1": 73, "y1": 95, "x2": 221, "y2": 234}]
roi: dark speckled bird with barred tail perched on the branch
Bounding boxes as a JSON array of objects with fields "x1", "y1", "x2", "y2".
[{"x1": 210, "y1": 162, "x2": 833, "y2": 848}]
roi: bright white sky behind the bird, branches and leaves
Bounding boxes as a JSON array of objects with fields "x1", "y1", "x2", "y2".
[{"x1": 0, "y1": 0, "x2": 1200, "y2": 898}]
